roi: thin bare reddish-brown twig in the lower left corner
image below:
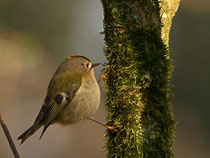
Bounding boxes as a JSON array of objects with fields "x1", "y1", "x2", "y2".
[{"x1": 0, "y1": 113, "x2": 20, "y2": 158}]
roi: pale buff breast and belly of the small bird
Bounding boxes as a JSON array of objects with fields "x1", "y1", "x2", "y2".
[{"x1": 59, "y1": 77, "x2": 100, "y2": 124}]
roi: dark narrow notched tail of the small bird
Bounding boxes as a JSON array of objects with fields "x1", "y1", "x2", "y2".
[{"x1": 18, "y1": 124, "x2": 41, "y2": 144}]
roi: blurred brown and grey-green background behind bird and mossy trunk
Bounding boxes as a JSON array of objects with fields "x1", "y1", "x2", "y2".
[{"x1": 0, "y1": 0, "x2": 210, "y2": 158}]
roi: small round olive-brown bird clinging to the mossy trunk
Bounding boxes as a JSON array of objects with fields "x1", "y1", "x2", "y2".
[{"x1": 18, "y1": 55, "x2": 101, "y2": 144}]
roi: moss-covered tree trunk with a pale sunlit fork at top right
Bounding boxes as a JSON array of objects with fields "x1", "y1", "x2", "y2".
[{"x1": 101, "y1": 0, "x2": 179, "y2": 158}]
